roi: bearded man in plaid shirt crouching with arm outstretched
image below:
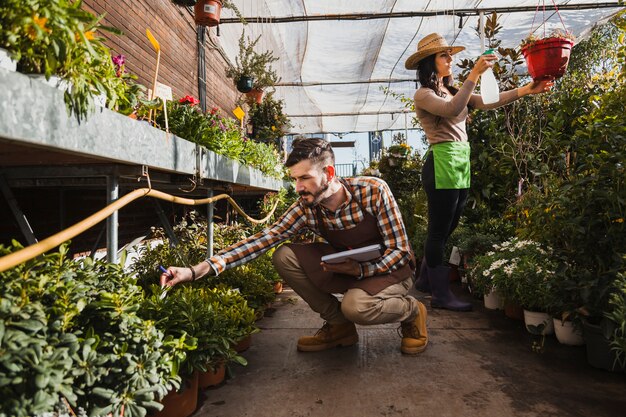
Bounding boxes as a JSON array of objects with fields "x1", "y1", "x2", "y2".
[{"x1": 161, "y1": 138, "x2": 428, "y2": 355}]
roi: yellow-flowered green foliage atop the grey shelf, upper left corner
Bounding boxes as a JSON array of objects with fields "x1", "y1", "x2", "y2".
[{"x1": 0, "y1": 0, "x2": 125, "y2": 121}]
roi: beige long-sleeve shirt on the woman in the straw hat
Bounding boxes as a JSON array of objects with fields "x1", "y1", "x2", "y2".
[{"x1": 414, "y1": 80, "x2": 519, "y2": 145}]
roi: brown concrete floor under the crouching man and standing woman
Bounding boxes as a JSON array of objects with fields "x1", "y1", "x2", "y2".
[{"x1": 193, "y1": 288, "x2": 626, "y2": 417}]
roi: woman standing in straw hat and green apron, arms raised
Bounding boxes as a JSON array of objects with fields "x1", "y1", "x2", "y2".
[{"x1": 405, "y1": 33, "x2": 553, "y2": 311}]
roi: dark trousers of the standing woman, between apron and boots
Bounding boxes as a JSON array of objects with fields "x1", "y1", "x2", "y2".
[{"x1": 422, "y1": 152, "x2": 469, "y2": 268}]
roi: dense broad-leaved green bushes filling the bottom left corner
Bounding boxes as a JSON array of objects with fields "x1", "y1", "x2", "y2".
[{"x1": 0, "y1": 243, "x2": 184, "y2": 417}]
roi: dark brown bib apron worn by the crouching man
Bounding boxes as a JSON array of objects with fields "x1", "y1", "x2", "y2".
[{"x1": 287, "y1": 181, "x2": 415, "y2": 295}]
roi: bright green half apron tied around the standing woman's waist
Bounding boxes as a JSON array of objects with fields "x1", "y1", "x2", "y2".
[{"x1": 426, "y1": 142, "x2": 471, "y2": 190}]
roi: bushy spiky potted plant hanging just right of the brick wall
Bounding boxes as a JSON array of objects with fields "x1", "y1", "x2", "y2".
[{"x1": 226, "y1": 32, "x2": 278, "y2": 96}]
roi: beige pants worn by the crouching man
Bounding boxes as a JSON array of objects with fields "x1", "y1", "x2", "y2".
[{"x1": 273, "y1": 245, "x2": 418, "y2": 324}]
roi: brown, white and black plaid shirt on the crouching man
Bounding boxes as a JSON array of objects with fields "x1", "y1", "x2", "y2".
[{"x1": 207, "y1": 177, "x2": 410, "y2": 277}]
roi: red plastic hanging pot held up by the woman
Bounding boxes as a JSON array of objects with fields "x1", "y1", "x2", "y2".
[{"x1": 522, "y1": 38, "x2": 574, "y2": 80}]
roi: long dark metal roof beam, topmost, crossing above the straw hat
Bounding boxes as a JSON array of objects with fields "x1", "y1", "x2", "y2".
[{"x1": 220, "y1": 1, "x2": 624, "y2": 25}]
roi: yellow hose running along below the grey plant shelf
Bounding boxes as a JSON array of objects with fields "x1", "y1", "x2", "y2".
[{"x1": 0, "y1": 188, "x2": 278, "y2": 272}]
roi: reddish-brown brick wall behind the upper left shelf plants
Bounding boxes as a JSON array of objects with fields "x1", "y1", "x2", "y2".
[{"x1": 83, "y1": 0, "x2": 239, "y2": 117}]
